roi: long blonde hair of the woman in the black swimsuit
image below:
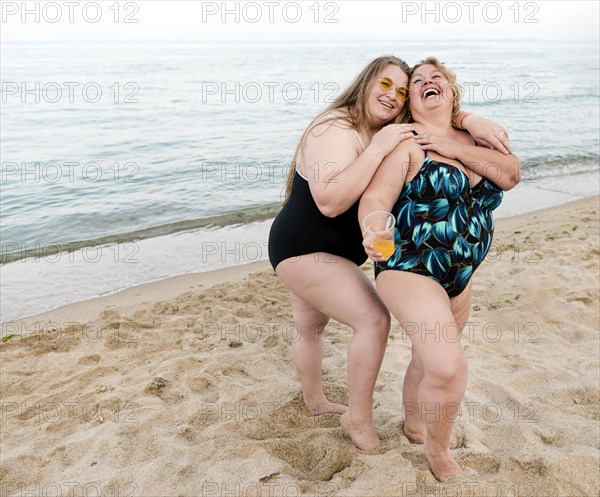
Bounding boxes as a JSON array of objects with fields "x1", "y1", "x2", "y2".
[{"x1": 283, "y1": 55, "x2": 410, "y2": 203}]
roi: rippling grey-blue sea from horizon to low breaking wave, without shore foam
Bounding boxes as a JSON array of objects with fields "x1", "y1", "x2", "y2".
[{"x1": 0, "y1": 41, "x2": 600, "y2": 262}]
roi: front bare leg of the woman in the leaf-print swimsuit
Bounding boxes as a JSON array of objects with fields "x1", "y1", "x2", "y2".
[{"x1": 377, "y1": 271, "x2": 467, "y2": 480}]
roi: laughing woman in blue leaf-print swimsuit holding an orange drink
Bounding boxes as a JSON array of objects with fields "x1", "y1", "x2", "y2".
[{"x1": 357, "y1": 57, "x2": 520, "y2": 481}]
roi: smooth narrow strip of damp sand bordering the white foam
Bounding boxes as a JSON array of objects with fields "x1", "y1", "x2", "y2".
[{"x1": 7, "y1": 192, "x2": 600, "y2": 335}]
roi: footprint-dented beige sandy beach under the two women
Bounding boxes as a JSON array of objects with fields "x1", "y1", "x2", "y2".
[{"x1": 0, "y1": 196, "x2": 600, "y2": 497}]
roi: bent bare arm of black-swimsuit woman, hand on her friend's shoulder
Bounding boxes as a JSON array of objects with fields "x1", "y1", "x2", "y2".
[{"x1": 302, "y1": 123, "x2": 412, "y2": 217}]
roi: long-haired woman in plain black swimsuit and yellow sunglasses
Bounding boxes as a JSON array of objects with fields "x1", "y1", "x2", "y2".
[{"x1": 269, "y1": 56, "x2": 509, "y2": 450}]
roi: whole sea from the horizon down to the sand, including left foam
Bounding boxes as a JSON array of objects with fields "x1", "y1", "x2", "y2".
[{"x1": 0, "y1": 40, "x2": 600, "y2": 322}]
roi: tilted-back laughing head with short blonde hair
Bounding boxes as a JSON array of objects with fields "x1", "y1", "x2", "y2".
[{"x1": 410, "y1": 57, "x2": 460, "y2": 119}]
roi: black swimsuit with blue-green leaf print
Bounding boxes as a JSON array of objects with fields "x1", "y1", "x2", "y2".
[{"x1": 375, "y1": 147, "x2": 503, "y2": 297}]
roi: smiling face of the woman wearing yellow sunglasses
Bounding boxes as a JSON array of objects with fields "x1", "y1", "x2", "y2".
[{"x1": 367, "y1": 64, "x2": 408, "y2": 127}]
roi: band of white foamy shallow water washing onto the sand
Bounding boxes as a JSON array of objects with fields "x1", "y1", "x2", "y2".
[{"x1": 0, "y1": 167, "x2": 600, "y2": 323}]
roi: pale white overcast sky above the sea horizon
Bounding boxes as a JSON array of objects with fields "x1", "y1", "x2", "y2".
[{"x1": 0, "y1": 0, "x2": 600, "y2": 42}]
